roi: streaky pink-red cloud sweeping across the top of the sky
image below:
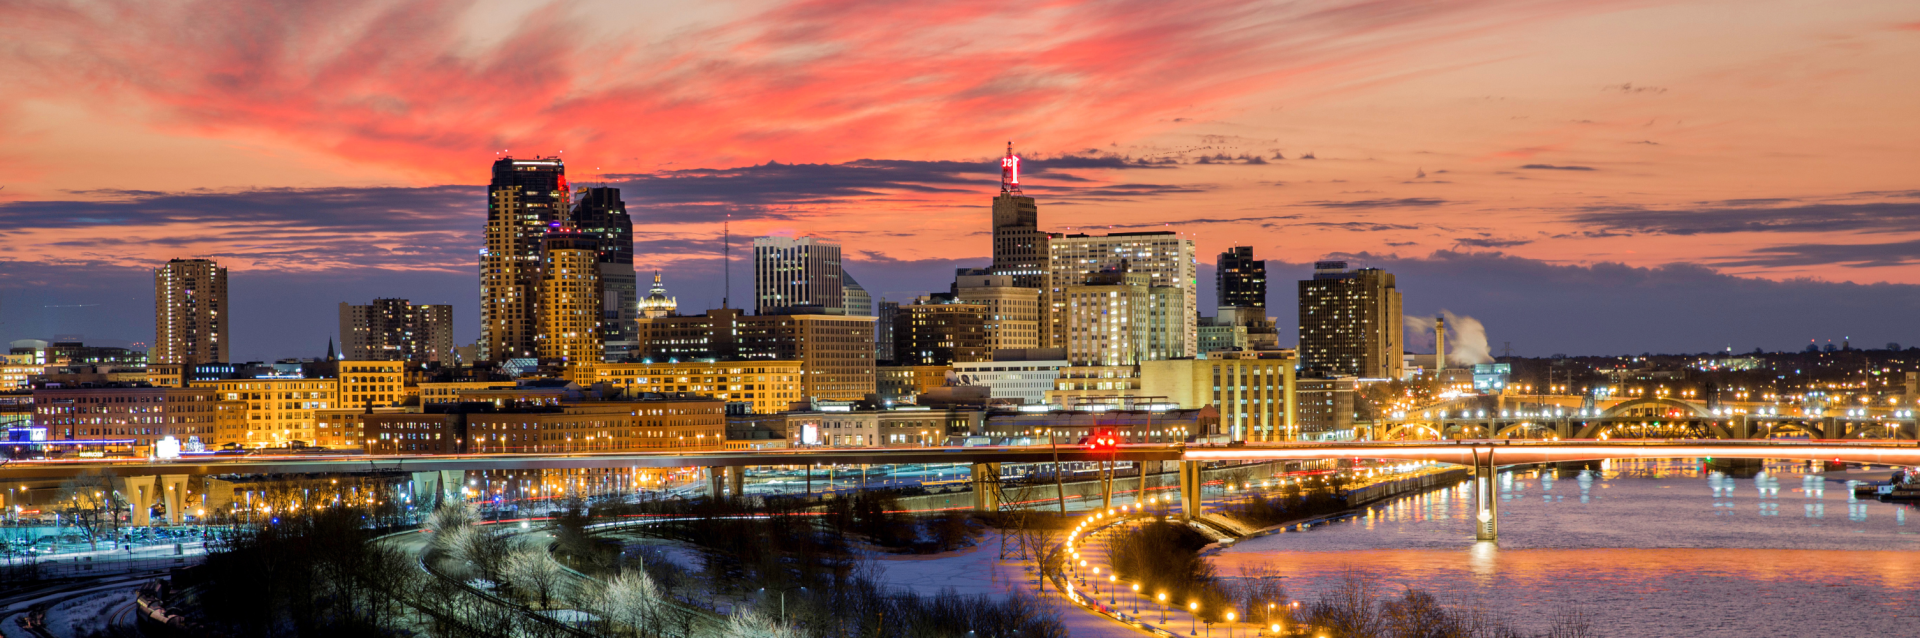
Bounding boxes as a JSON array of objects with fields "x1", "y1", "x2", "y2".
[{"x1": 0, "y1": 0, "x2": 1620, "y2": 183}]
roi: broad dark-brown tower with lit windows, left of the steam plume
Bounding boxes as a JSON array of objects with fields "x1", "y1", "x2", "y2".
[{"x1": 1300, "y1": 261, "x2": 1405, "y2": 379}]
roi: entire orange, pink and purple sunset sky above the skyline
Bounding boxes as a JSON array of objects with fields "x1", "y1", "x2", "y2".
[{"x1": 0, "y1": 2, "x2": 1920, "y2": 359}]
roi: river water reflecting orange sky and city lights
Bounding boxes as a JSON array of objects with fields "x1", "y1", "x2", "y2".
[{"x1": 1213, "y1": 459, "x2": 1920, "y2": 638}]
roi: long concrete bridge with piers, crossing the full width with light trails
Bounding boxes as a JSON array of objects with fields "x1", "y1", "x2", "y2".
[{"x1": 0, "y1": 438, "x2": 1920, "y2": 540}]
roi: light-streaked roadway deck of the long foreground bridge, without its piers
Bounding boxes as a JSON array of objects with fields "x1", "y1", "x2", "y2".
[{"x1": 0, "y1": 440, "x2": 1920, "y2": 479}]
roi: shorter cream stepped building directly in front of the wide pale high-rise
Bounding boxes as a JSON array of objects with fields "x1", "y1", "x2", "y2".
[{"x1": 1056, "y1": 261, "x2": 1192, "y2": 365}]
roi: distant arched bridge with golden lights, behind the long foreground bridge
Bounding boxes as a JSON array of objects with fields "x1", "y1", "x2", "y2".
[{"x1": 1371, "y1": 396, "x2": 1920, "y2": 440}]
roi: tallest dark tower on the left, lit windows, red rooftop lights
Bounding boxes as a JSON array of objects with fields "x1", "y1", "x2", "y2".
[{"x1": 480, "y1": 158, "x2": 568, "y2": 361}]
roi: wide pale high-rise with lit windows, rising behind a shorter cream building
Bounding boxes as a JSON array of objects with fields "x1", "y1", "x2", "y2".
[{"x1": 1041, "y1": 231, "x2": 1200, "y2": 357}]
